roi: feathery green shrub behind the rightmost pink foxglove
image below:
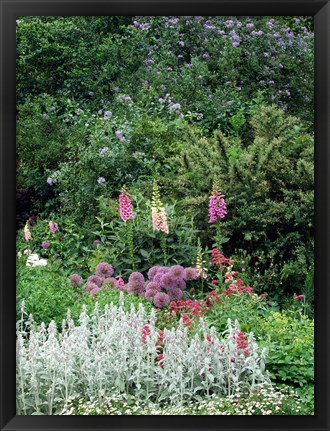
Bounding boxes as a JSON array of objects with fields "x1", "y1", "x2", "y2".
[{"x1": 175, "y1": 106, "x2": 314, "y2": 294}]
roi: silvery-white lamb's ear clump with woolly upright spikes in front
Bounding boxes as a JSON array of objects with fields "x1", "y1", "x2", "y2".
[{"x1": 17, "y1": 292, "x2": 268, "y2": 415}]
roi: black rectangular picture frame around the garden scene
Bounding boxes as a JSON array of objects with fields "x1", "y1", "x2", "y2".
[{"x1": 0, "y1": 0, "x2": 330, "y2": 431}]
